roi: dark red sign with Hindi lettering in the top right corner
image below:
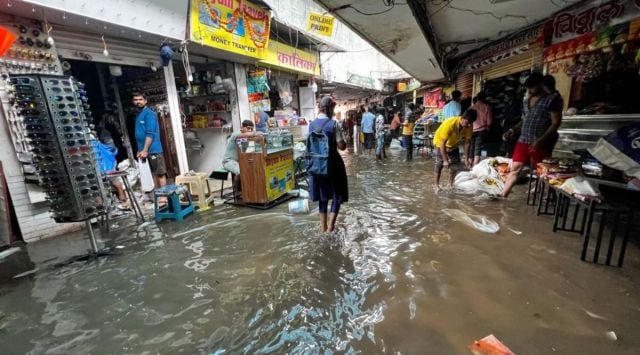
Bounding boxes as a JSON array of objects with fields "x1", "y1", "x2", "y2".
[{"x1": 551, "y1": 0, "x2": 640, "y2": 44}]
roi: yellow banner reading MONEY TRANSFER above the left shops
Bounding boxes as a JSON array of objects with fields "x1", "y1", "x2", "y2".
[{"x1": 190, "y1": 0, "x2": 271, "y2": 59}]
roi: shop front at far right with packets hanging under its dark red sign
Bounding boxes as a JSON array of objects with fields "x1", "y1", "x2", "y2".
[{"x1": 544, "y1": 0, "x2": 640, "y2": 155}]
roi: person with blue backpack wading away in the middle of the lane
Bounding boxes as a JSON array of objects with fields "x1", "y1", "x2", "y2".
[{"x1": 307, "y1": 97, "x2": 349, "y2": 233}]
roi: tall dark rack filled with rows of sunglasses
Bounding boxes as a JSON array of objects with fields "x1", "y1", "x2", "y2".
[{"x1": 10, "y1": 75, "x2": 107, "y2": 223}]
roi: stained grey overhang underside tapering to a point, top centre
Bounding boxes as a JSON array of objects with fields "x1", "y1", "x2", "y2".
[{"x1": 316, "y1": 0, "x2": 444, "y2": 81}]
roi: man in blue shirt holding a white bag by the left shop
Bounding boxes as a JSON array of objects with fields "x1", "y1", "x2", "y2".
[{"x1": 133, "y1": 92, "x2": 167, "y2": 191}]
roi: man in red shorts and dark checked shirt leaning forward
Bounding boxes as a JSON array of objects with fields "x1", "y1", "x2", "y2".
[{"x1": 502, "y1": 73, "x2": 562, "y2": 197}]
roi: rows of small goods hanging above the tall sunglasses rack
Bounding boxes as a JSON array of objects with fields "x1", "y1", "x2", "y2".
[{"x1": 0, "y1": 15, "x2": 62, "y2": 76}]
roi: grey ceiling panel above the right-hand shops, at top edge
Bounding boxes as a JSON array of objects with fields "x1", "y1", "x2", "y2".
[{"x1": 423, "y1": 0, "x2": 582, "y2": 56}]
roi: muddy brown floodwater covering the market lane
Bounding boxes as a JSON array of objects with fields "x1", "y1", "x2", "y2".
[{"x1": 0, "y1": 152, "x2": 640, "y2": 354}]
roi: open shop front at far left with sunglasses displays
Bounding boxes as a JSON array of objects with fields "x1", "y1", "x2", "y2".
[{"x1": 0, "y1": 7, "x2": 182, "y2": 241}]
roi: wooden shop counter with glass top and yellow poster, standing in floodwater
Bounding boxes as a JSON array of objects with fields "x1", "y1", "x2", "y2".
[{"x1": 236, "y1": 132, "x2": 295, "y2": 205}]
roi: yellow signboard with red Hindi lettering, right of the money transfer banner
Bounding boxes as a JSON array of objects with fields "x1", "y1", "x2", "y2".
[{"x1": 260, "y1": 40, "x2": 320, "y2": 75}]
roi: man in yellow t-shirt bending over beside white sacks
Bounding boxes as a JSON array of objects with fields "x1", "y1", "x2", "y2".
[{"x1": 433, "y1": 109, "x2": 478, "y2": 190}]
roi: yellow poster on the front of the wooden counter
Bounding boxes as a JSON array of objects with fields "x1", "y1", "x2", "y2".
[{"x1": 265, "y1": 149, "x2": 295, "y2": 201}]
